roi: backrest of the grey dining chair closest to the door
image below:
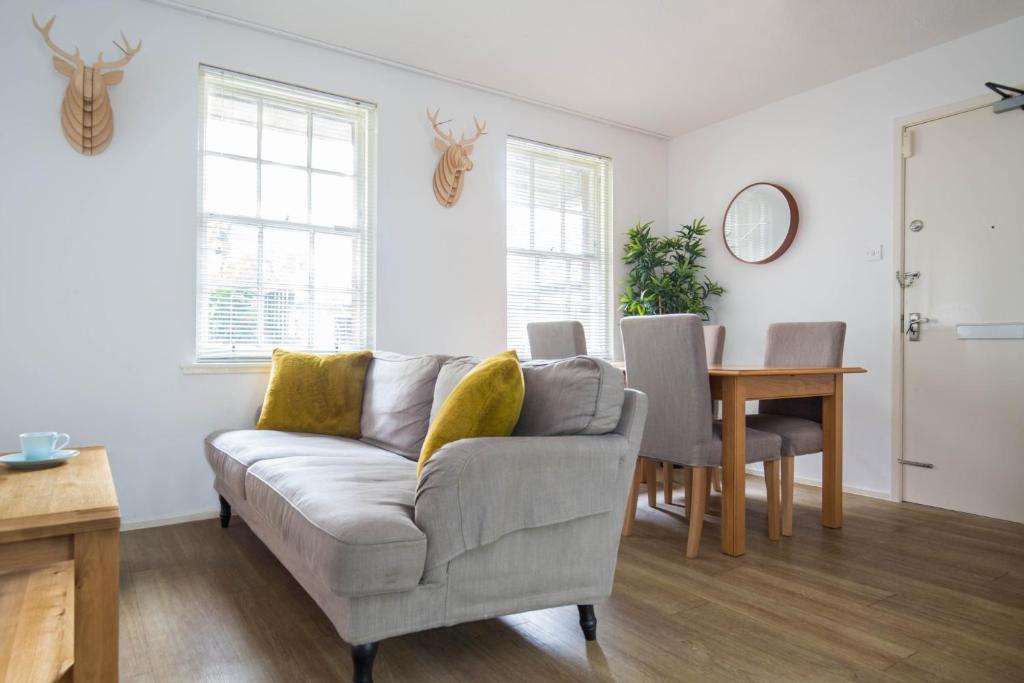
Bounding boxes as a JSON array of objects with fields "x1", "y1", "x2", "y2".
[{"x1": 758, "y1": 321, "x2": 846, "y2": 422}]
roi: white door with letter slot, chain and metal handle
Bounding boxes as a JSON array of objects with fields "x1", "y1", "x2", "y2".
[{"x1": 902, "y1": 100, "x2": 1024, "y2": 522}]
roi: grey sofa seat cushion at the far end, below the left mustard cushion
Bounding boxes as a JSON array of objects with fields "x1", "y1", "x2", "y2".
[{"x1": 206, "y1": 429, "x2": 381, "y2": 498}]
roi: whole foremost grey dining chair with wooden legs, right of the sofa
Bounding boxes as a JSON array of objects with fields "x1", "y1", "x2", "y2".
[{"x1": 621, "y1": 313, "x2": 782, "y2": 557}]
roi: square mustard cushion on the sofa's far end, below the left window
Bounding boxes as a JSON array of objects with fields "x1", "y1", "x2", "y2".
[{"x1": 256, "y1": 348, "x2": 373, "y2": 438}]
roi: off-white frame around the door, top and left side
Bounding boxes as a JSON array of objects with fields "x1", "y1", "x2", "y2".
[{"x1": 890, "y1": 95, "x2": 998, "y2": 503}]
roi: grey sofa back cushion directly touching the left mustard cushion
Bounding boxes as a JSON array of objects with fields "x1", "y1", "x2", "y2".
[{"x1": 362, "y1": 352, "x2": 445, "y2": 460}]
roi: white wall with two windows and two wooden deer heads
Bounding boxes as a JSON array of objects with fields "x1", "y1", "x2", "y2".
[{"x1": 0, "y1": 0, "x2": 668, "y2": 522}]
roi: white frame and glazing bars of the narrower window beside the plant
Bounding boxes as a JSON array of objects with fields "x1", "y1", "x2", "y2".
[{"x1": 505, "y1": 135, "x2": 614, "y2": 358}]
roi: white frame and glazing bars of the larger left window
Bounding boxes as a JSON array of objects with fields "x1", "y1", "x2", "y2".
[{"x1": 192, "y1": 65, "x2": 377, "y2": 362}]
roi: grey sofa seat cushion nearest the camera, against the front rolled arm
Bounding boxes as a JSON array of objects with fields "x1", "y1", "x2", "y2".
[{"x1": 246, "y1": 449, "x2": 427, "y2": 596}]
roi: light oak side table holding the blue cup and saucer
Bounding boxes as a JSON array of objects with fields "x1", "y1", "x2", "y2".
[{"x1": 0, "y1": 446, "x2": 121, "y2": 683}]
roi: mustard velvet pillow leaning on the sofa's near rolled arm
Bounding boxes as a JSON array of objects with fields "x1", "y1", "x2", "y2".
[{"x1": 416, "y1": 351, "x2": 526, "y2": 476}]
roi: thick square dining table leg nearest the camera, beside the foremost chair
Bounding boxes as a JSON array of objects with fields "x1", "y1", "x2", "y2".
[{"x1": 721, "y1": 377, "x2": 746, "y2": 556}]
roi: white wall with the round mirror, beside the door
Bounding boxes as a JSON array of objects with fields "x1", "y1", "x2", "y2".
[{"x1": 662, "y1": 18, "x2": 1024, "y2": 495}]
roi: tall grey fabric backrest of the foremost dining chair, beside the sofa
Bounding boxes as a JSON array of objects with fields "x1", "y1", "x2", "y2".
[{"x1": 620, "y1": 313, "x2": 712, "y2": 465}]
